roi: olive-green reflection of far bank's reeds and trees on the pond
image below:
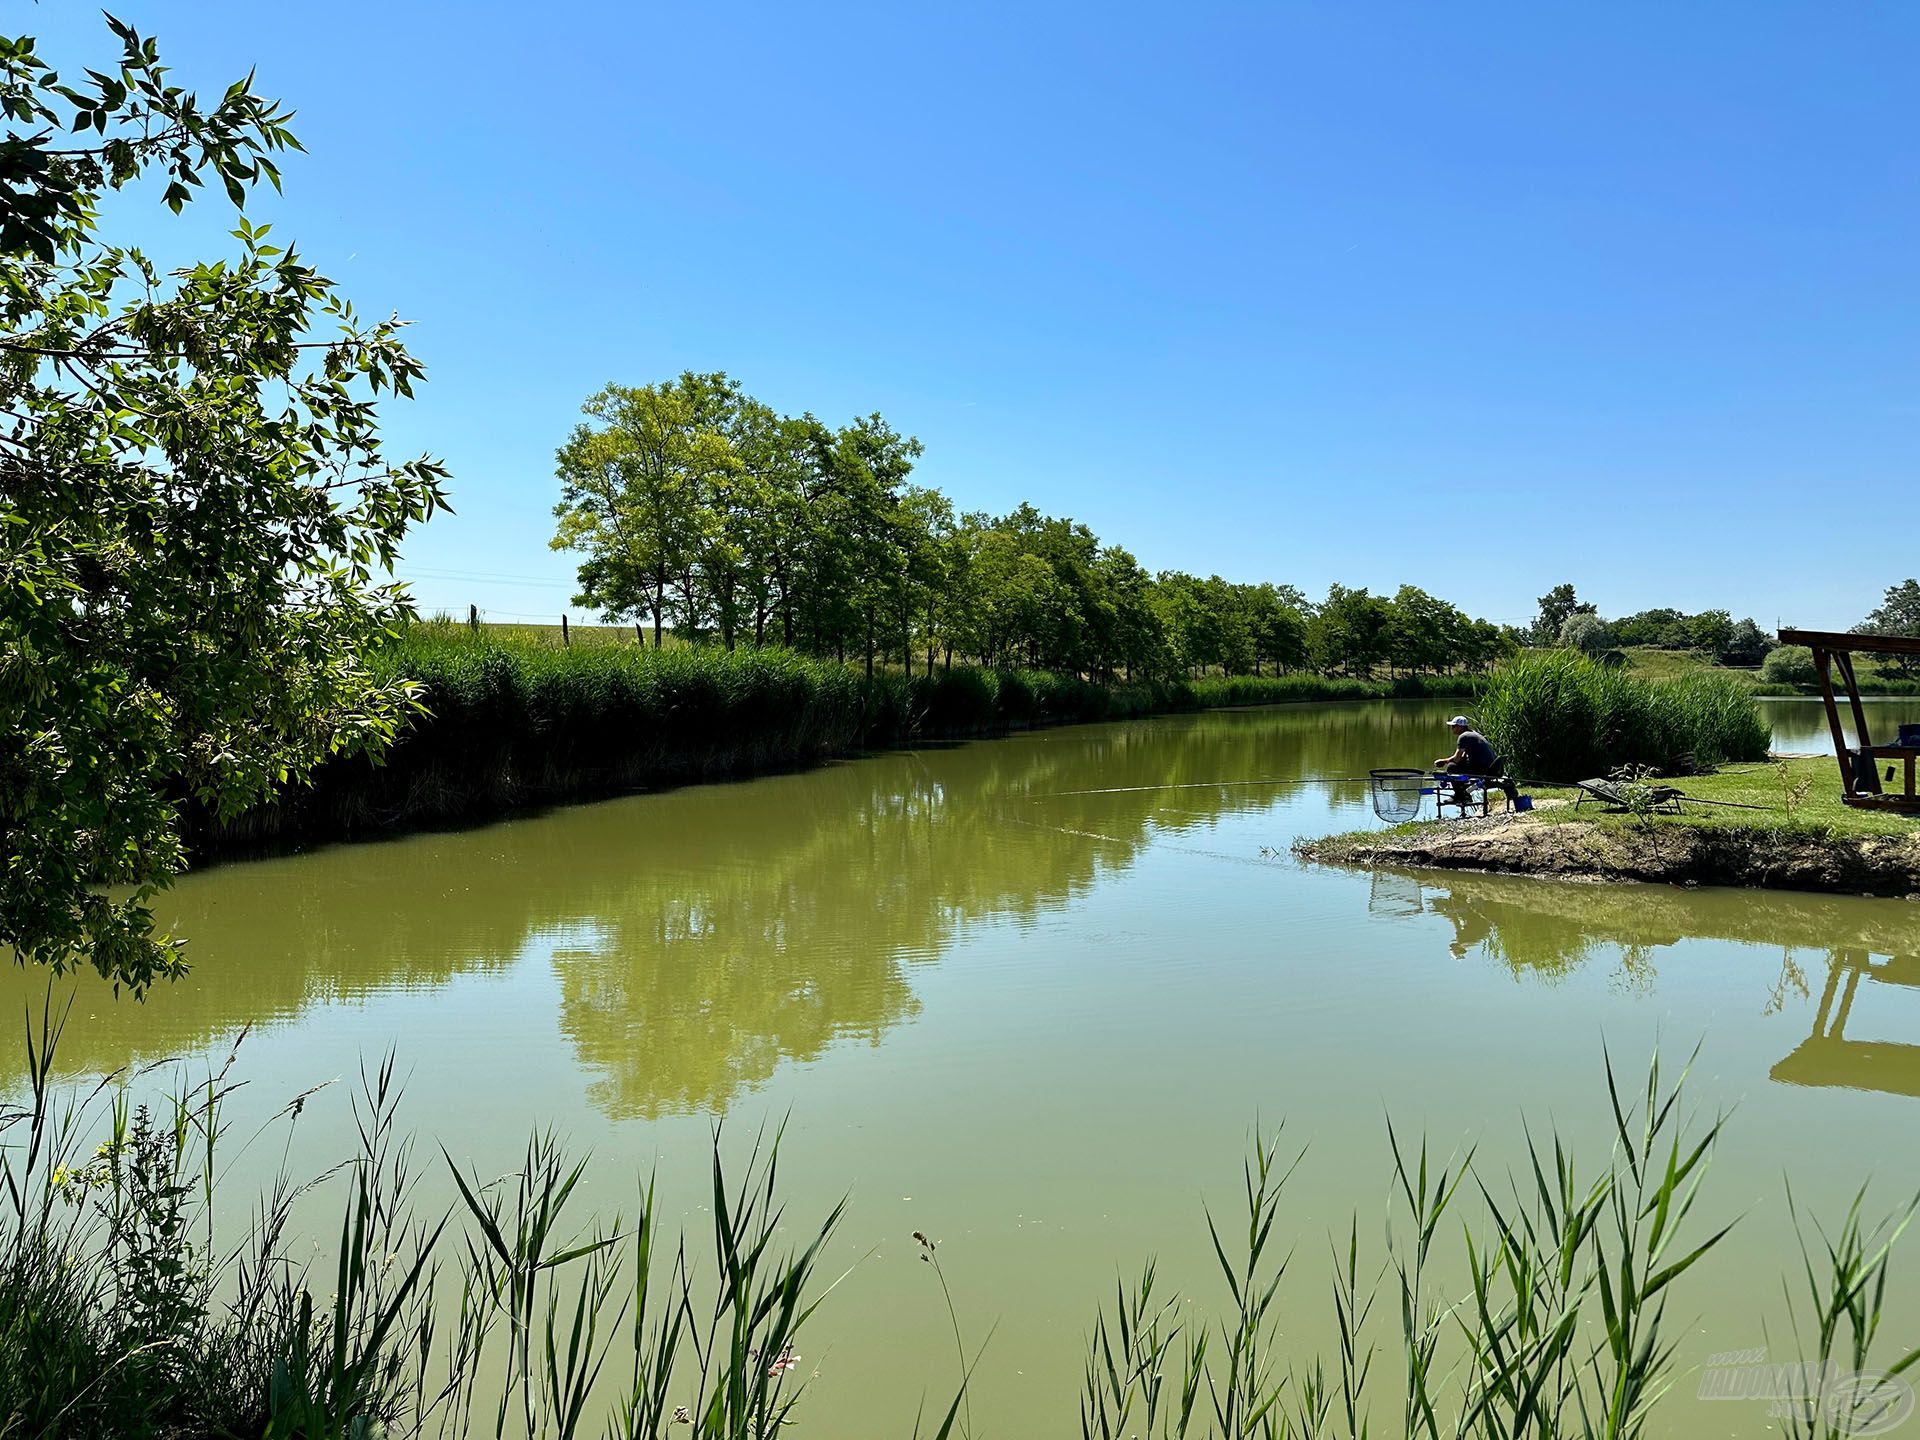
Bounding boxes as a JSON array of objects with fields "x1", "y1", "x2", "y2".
[{"x1": 0, "y1": 705, "x2": 1442, "y2": 1114}]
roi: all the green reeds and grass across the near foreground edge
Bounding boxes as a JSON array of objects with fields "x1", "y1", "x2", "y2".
[{"x1": 0, "y1": 1033, "x2": 1920, "y2": 1440}]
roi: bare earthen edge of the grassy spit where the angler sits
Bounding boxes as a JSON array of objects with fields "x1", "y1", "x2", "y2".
[{"x1": 1292, "y1": 812, "x2": 1920, "y2": 899}]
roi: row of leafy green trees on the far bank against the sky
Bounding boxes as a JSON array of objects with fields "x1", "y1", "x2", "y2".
[{"x1": 553, "y1": 372, "x2": 1515, "y2": 678}]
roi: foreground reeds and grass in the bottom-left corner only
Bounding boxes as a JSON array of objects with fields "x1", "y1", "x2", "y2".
[{"x1": 0, "y1": 1025, "x2": 913, "y2": 1440}]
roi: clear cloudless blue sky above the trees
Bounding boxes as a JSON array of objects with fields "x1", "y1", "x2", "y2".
[{"x1": 33, "y1": 0, "x2": 1920, "y2": 624}]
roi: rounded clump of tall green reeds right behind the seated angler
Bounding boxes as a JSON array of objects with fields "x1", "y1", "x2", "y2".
[{"x1": 1476, "y1": 651, "x2": 1772, "y2": 781}]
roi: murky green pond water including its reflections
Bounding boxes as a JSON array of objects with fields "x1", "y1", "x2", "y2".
[{"x1": 11, "y1": 703, "x2": 1920, "y2": 1436}]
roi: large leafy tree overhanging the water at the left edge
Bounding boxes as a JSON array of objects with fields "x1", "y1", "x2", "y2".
[{"x1": 0, "y1": 19, "x2": 445, "y2": 989}]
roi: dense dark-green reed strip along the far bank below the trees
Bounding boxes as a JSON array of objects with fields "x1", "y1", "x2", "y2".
[{"x1": 190, "y1": 624, "x2": 1469, "y2": 854}]
